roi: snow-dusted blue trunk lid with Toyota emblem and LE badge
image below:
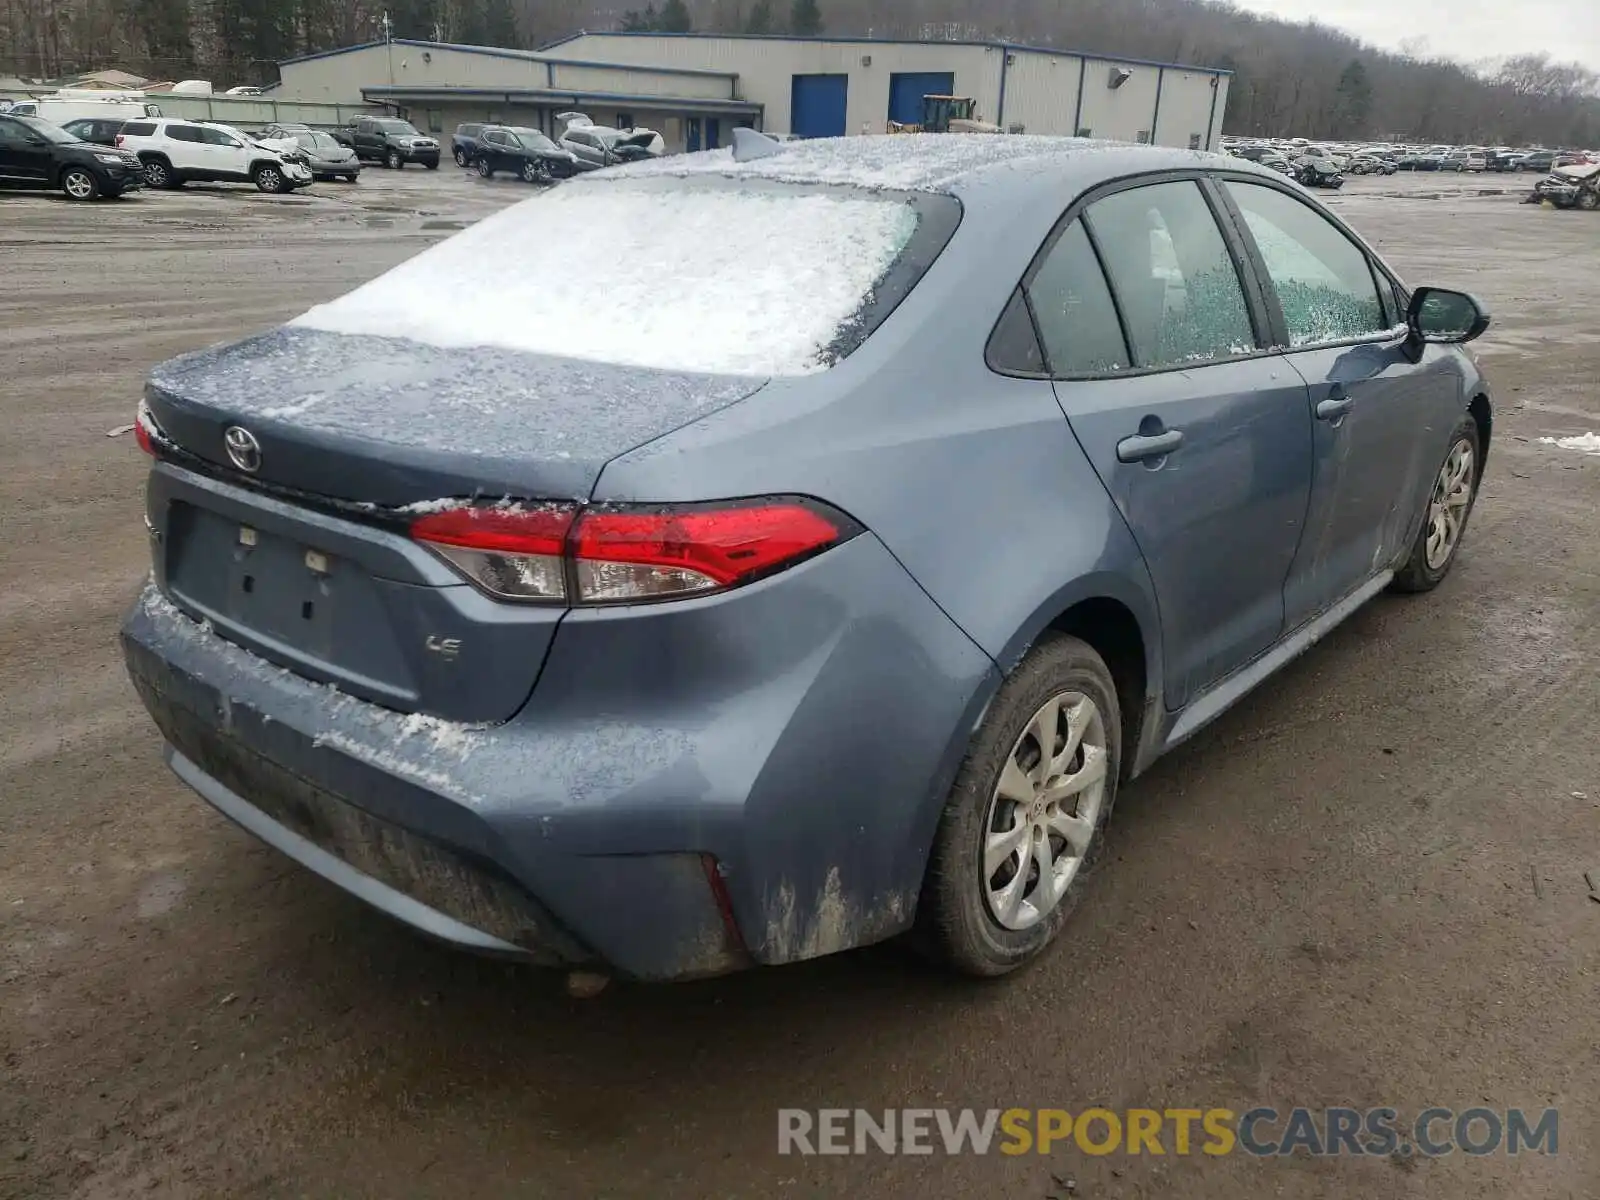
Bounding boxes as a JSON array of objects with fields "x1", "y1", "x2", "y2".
[{"x1": 146, "y1": 328, "x2": 765, "y2": 723}]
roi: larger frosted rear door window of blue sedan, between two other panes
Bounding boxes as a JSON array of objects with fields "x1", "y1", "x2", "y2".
[{"x1": 1088, "y1": 181, "x2": 1256, "y2": 368}]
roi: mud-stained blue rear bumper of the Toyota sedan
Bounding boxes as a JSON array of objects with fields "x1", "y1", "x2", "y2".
[{"x1": 123, "y1": 534, "x2": 997, "y2": 979}]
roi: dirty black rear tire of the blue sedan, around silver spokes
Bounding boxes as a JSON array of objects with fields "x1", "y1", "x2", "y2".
[{"x1": 917, "y1": 634, "x2": 1122, "y2": 978}]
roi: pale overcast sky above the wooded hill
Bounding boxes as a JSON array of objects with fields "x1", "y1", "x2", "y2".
[{"x1": 1234, "y1": 0, "x2": 1600, "y2": 70}]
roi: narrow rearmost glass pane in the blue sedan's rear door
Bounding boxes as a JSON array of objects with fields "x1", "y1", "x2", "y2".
[{"x1": 1027, "y1": 221, "x2": 1128, "y2": 374}]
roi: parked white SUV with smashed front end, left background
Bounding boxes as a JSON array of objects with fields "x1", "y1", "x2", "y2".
[{"x1": 117, "y1": 117, "x2": 312, "y2": 192}]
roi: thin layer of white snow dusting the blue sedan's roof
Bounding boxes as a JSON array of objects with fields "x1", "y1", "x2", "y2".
[{"x1": 605, "y1": 133, "x2": 1209, "y2": 192}]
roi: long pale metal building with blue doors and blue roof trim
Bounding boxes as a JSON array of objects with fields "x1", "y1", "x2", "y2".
[{"x1": 269, "y1": 34, "x2": 1230, "y2": 150}]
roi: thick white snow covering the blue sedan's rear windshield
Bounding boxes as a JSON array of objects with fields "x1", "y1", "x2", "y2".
[{"x1": 291, "y1": 184, "x2": 917, "y2": 376}]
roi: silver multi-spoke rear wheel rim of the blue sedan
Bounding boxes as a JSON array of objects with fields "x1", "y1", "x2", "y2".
[{"x1": 981, "y1": 691, "x2": 1107, "y2": 930}]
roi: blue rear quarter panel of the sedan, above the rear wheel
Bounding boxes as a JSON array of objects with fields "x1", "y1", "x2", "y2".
[{"x1": 594, "y1": 167, "x2": 1160, "y2": 790}]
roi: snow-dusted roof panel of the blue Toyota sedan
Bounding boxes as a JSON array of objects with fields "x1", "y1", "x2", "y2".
[{"x1": 605, "y1": 133, "x2": 1270, "y2": 195}]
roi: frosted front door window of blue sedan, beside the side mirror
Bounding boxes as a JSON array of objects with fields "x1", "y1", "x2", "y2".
[{"x1": 1227, "y1": 182, "x2": 1390, "y2": 346}]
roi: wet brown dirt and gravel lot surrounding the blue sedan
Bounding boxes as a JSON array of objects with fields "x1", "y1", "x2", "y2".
[{"x1": 0, "y1": 165, "x2": 1600, "y2": 1200}]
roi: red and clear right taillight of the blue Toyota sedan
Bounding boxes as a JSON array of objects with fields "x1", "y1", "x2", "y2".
[{"x1": 411, "y1": 498, "x2": 859, "y2": 605}]
